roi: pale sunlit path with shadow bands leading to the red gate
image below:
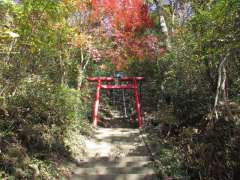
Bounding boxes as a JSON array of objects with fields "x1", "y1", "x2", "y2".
[{"x1": 70, "y1": 127, "x2": 157, "y2": 180}]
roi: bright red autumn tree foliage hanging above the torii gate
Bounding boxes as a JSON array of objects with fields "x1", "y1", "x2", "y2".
[{"x1": 92, "y1": 0, "x2": 162, "y2": 70}]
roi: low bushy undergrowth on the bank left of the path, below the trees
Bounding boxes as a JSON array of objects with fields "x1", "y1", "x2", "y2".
[{"x1": 0, "y1": 77, "x2": 92, "y2": 179}]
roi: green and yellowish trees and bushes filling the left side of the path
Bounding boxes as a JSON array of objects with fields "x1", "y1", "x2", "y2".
[{"x1": 0, "y1": 0, "x2": 94, "y2": 179}]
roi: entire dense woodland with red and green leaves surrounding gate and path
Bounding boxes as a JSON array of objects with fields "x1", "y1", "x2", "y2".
[{"x1": 0, "y1": 0, "x2": 240, "y2": 180}]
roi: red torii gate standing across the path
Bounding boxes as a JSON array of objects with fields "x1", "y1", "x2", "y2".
[{"x1": 88, "y1": 77, "x2": 144, "y2": 128}]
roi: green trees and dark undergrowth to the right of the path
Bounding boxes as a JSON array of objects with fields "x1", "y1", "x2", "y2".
[{"x1": 166, "y1": 1, "x2": 239, "y2": 179}]
